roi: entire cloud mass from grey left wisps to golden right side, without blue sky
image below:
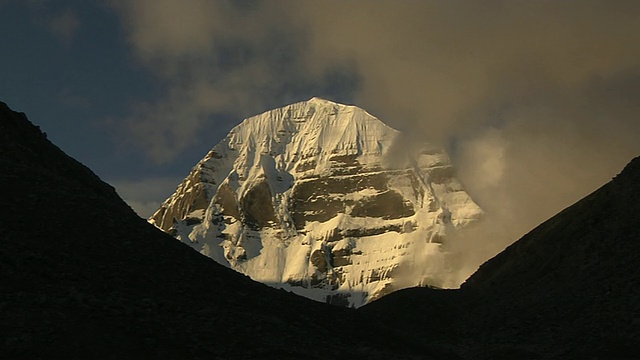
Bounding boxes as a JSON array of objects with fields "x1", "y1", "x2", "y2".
[{"x1": 115, "y1": 0, "x2": 640, "y2": 282}]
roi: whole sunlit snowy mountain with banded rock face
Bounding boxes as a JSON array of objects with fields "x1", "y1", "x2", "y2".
[{"x1": 150, "y1": 98, "x2": 482, "y2": 307}]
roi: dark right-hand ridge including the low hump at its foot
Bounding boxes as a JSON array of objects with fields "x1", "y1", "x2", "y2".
[{"x1": 361, "y1": 158, "x2": 640, "y2": 359}]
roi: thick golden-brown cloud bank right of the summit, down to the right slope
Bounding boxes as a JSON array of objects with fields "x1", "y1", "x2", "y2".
[{"x1": 288, "y1": 1, "x2": 640, "y2": 282}]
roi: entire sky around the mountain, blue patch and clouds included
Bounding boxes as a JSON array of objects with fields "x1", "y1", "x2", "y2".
[{"x1": 0, "y1": 0, "x2": 640, "y2": 255}]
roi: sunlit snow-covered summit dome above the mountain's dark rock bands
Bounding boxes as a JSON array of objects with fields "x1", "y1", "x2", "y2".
[{"x1": 220, "y1": 98, "x2": 398, "y2": 162}]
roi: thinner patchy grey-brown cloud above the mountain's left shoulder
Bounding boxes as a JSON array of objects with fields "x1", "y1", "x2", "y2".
[{"x1": 113, "y1": 0, "x2": 357, "y2": 164}]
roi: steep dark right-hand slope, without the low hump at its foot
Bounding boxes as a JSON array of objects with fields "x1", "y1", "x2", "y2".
[{"x1": 463, "y1": 158, "x2": 640, "y2": 359}]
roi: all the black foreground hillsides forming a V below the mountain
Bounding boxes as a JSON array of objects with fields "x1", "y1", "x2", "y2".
[{"x1": 0, "y1": 103, "x2": 640, "y2": 359}]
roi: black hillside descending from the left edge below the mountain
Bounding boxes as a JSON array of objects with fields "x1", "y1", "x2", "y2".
[{"x1": 0, "y1": 103, "x2": 437, "y2": 359}]
